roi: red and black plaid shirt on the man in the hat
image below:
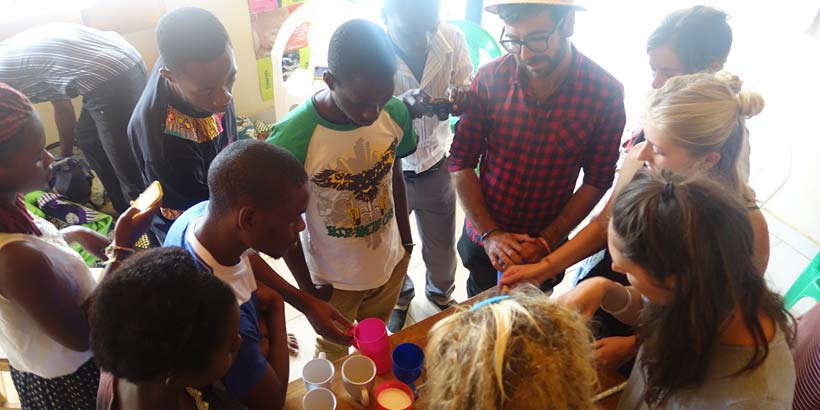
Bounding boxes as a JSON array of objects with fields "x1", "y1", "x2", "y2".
[{"x1": 449, "y1": 47, "x2": 626, "y2": 243}]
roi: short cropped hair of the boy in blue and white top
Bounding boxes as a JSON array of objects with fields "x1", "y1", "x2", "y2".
[{"x1": 208, "y1": 140, "x2": 308, "y2": 215}]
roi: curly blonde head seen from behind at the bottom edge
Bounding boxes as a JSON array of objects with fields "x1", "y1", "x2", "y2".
[{"x1": 422, "y1": 285, "x2": 597, "y2": 410}]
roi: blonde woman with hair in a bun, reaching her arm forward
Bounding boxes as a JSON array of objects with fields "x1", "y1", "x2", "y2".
[{"x1": 501, "y1": 73, "x2": 769, "y2": 367}]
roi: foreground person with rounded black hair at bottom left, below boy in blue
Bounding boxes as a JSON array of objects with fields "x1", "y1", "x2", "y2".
[{"x1": 91, "y1": 248, "x2": 241, "y2": 410}]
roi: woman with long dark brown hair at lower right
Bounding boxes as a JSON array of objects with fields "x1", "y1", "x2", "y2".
[{"x1": 564, "y1": 171, "x2": 795, "y2": 409}]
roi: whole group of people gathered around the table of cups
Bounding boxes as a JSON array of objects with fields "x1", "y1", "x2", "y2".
[{"x1": 0, "y1": 0, "x2": 820, "y2": 409}]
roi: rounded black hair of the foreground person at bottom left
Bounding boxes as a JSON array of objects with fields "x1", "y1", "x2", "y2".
[{"x1": 90, "y1": 248, "x2": 236, "y2": 383}]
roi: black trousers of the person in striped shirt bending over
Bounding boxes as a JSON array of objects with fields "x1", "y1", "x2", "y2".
[{"x1": 75, "y1": 64, "x2": 148, "y2": 212}]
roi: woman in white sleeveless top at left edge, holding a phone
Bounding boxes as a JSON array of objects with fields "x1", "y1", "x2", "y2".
[{"x1": 0, "y1": 83, "x2": 156, "y2": 409}]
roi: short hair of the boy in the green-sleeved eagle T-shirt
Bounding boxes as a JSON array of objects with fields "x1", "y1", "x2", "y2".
[{"x1": 327, "y1": 20, "x2": 396, "y2": 82}]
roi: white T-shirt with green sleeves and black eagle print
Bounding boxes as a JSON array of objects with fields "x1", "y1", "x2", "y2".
[{"x1": 268, "y1": 98, "x2": 416, "y2": 291}]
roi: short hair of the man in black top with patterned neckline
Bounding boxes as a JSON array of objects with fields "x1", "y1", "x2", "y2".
[{"x1": 157, "y1": 7, "x2": 231, "y2": 70}]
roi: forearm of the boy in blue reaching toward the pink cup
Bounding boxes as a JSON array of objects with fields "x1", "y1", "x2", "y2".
[{"x1": 249, "y1": 251, "x2": 353, "y2": 345}]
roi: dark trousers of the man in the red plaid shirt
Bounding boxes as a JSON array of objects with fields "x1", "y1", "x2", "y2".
[{"x1": 456, "y1": 227, "x2": 564, "y2": 297}]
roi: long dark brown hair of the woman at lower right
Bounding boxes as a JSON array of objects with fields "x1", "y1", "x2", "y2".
[{"x1": 612, "y1": 172, "x2": 793, "y2": 405}]
